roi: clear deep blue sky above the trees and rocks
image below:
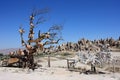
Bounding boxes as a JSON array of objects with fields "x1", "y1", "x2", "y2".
[{"x1": 0, "y1": 0, "x2": 120, "y2": 49}]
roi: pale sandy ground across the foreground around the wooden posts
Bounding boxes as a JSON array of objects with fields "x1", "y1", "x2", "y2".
[{"x1": 0, "y1": 52, "x2": 120, "y2": 80}]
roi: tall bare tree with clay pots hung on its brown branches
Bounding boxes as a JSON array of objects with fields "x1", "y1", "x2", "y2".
[{"x1": 19, "y1": 9, "x2": 61, "y2": 70}]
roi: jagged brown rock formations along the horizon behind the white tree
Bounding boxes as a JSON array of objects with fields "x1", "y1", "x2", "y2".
[{"x1": 56, "y1": 37, "x2": 120, "y2": 52}]
